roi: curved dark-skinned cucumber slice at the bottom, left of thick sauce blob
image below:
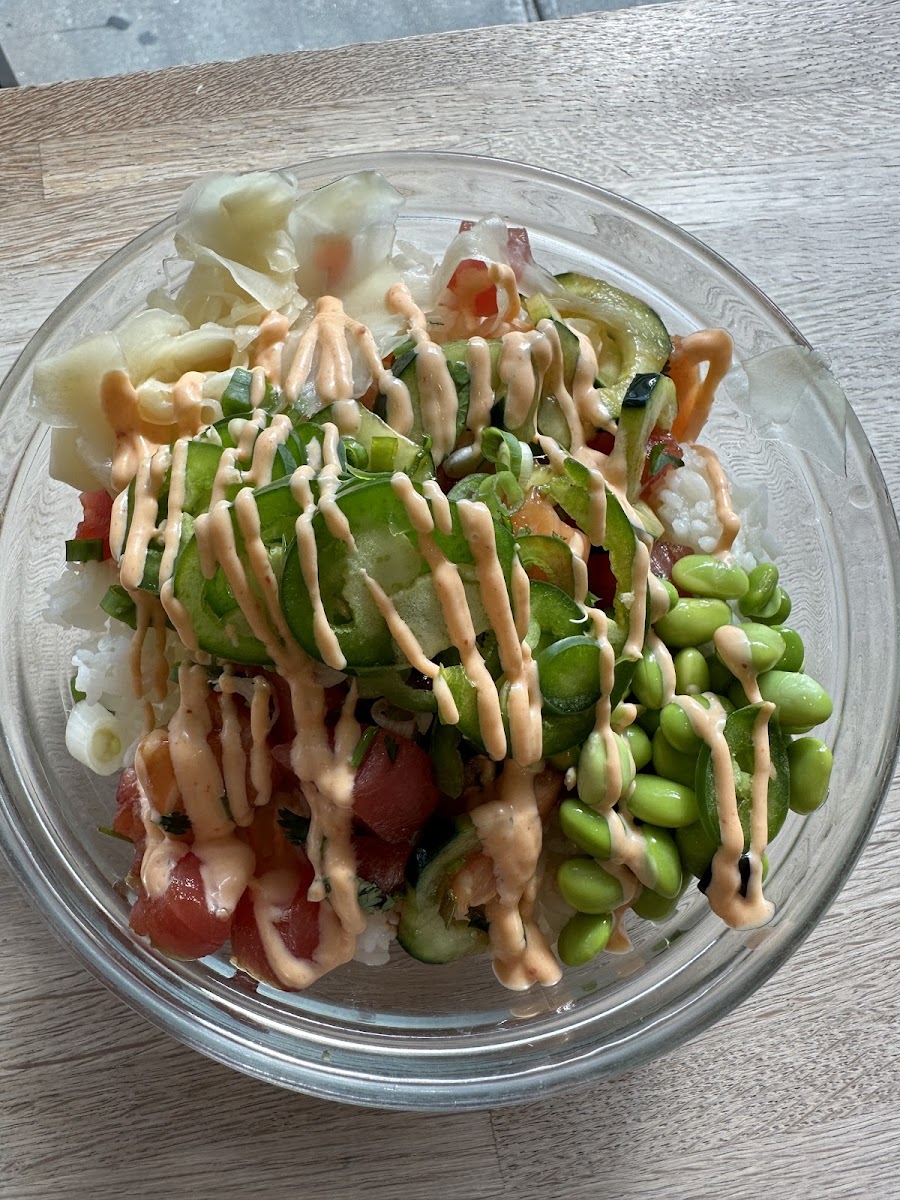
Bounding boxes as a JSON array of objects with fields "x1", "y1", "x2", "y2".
[{"x1": 397, "y1": 817, "x2": 487, "y2": 962}]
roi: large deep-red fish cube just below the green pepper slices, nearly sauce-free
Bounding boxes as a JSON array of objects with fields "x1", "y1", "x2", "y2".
[{"x1": 353, "y1": 730, "x2": 440, "y2": 842}]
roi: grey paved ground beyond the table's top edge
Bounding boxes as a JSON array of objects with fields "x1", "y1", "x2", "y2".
[{"x1": 0, "y1": 0, "x2": 653, "y2": 86}]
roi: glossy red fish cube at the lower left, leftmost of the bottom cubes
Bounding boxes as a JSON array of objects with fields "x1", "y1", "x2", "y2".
[{"x1": 131, "y1": 851, "x2": 232, "y2": 959}]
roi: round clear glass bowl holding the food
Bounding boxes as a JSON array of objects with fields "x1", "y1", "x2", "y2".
[{"x1": 0, "y1": 154, "x2": 900, "y2": 1109}]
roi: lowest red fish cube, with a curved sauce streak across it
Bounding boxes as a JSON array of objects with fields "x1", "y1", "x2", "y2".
[{"x1": 232, "y1": 856, "x2": 320, "y2": 988}]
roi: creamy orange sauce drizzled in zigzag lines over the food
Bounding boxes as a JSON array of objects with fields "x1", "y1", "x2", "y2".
[{"x1": 102, "y1": 234, "x2": 748, "y2": 989}]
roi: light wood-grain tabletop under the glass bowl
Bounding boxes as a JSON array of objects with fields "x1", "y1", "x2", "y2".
[{"x1": 0, "y1": 0, "x2": 900, "y2": 1200}]
